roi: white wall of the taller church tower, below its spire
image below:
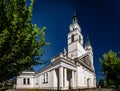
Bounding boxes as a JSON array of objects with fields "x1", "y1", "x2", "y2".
[{"x1": 68, "y1": 30, "x2": 85, "y2": 58}]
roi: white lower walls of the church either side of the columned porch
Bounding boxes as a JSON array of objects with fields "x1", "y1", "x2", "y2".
[{"x1": 17, "y1": 59, "x2": 95, "y2": 89}]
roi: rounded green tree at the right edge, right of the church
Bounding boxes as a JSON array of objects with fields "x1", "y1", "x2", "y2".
[{"x1": 100, "y1": 50, "x2": 120, "y2": 88}]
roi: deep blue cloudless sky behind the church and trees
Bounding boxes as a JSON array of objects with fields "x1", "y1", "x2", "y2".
[{"x1": 29, "y1": 0, "x2": 120, "y2": 83}]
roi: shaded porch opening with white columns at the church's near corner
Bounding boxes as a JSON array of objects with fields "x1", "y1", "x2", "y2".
[{"x1": 55, "y1": 67, "x2": 74, "y2": 91}]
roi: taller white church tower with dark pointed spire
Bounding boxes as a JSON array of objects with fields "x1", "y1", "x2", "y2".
[{"x1": 68, "y1": 11, "x2": 85, "y2": 59}]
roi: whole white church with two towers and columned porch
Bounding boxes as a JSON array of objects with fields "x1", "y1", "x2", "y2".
[{"x1": 16, "y1": 13, "x2": 96, "y2": 90}]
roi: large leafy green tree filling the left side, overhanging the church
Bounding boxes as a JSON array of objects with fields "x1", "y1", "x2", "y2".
[{"x1": 0, "y1": 0, "x2": 47, "y2": 82}]
